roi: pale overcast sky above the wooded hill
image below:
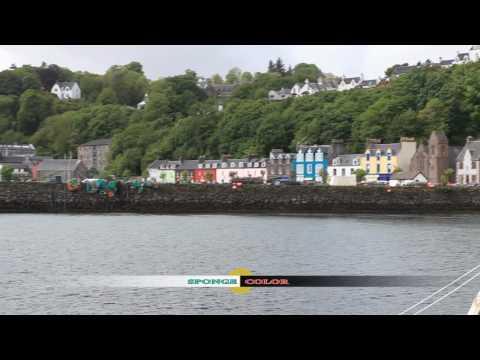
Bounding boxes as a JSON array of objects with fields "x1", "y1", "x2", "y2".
[{"x1": 0, "y1": 45, "x2": 469, "y2": 80}]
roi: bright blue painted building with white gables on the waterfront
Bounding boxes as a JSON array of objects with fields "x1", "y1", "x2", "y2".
[{"x1": 295, "y1": 145, "x2": 338, "y2": 183}]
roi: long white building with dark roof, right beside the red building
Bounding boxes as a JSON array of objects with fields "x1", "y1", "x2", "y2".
[{"x1": 216, "y1": 157, "x2": 268, "y2": 184}]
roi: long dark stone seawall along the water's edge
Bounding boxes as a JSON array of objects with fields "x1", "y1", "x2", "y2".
[{"x1": 0, "y1": 183, "x2": 480, "y2": 213}]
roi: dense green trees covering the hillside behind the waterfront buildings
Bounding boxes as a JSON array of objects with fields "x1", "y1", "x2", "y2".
[{"x1": 0, "y1": 59, "x2": 480, "y2": 175}]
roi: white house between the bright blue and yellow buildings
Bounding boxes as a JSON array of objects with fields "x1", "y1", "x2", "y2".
[{"x1": 328, "y1": 154, "x2": 363, "y2": 186}]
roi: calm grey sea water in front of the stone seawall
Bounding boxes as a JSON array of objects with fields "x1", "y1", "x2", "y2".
[{"x1": 0, "y1": 214, "x2": 480, "y2": 314}]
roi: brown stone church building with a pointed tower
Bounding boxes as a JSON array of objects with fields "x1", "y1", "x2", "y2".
[{"x1": 408, "y1": 131, "x2": 461, "y2": 184}]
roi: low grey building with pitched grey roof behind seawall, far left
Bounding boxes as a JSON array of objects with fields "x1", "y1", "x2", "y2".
[{"x1": 32, "y1": 159, "x2": 88, "y2": 182}]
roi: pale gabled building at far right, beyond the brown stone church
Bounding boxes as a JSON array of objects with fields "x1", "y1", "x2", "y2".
[{"x1": 456, "y1": 136, "x2": 480, "y2": 185}]
